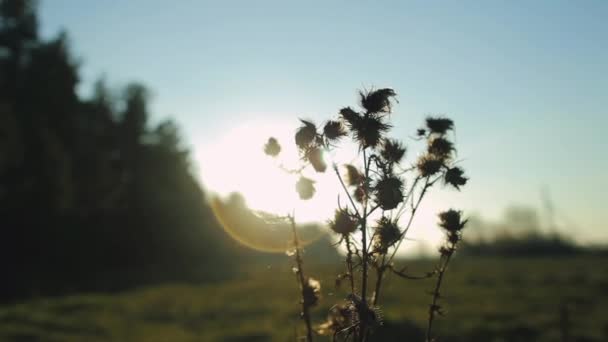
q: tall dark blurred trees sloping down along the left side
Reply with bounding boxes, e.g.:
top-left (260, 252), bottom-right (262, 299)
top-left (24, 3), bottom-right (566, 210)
top-left (0, 0), bottom-right (234, 300)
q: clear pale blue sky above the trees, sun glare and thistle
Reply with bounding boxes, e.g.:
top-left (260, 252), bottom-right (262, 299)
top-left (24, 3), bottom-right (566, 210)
top-left (40, 0), bottom-right (608, 242)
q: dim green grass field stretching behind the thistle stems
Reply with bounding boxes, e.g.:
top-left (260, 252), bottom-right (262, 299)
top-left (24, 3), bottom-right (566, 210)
top-left (0, 257), bottom-right (608, 342)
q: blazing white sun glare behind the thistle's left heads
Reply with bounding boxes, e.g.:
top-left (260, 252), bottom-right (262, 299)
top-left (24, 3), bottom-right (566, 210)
top-left (197, 122), bottom-right (340, 223)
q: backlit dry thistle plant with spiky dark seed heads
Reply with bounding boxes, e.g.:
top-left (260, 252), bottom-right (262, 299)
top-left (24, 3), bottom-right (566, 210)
top-left (264, 88), bottom-right (468, 341)
